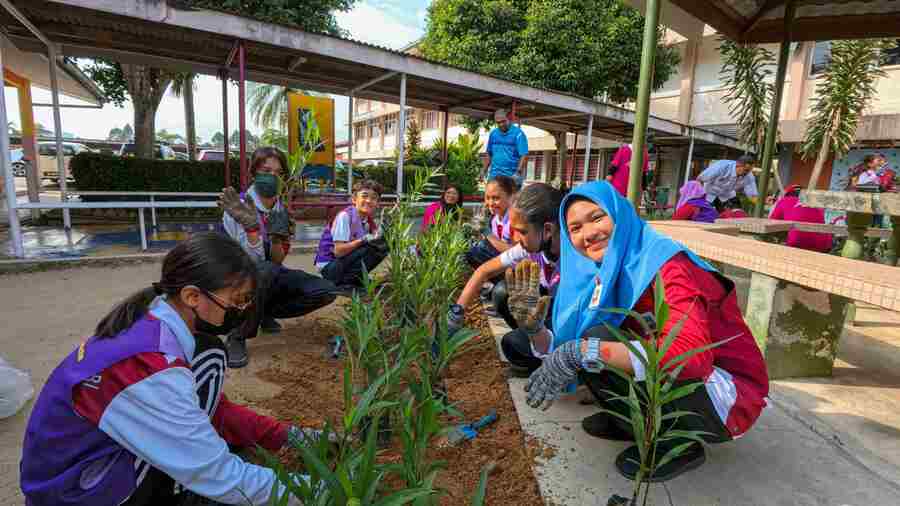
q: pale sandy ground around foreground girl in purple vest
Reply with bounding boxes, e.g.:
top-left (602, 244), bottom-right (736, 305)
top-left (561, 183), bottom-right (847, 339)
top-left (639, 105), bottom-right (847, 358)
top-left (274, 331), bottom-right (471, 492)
top-left (0, 256), bottom-right (324, 506)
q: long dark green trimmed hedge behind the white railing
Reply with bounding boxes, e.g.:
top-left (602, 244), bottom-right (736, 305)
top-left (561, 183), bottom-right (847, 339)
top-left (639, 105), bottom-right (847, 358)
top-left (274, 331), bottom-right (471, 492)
top-left (69, 153), bottom-right (240, 201)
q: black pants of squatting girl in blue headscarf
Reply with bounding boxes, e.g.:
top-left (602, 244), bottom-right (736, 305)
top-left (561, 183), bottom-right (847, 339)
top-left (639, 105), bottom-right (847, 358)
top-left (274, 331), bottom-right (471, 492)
top-left (579, 326), bottom-right (731, 443)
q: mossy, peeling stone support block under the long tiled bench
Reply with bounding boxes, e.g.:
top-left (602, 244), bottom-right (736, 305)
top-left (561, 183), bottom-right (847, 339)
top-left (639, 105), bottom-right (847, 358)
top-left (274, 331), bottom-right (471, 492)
top-left (744, 272), bottom-right (851, 380)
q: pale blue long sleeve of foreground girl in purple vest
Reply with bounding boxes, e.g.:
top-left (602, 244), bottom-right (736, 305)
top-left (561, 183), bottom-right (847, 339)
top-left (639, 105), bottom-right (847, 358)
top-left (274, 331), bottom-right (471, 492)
top-left (99, 367), bottom-right (283, 505)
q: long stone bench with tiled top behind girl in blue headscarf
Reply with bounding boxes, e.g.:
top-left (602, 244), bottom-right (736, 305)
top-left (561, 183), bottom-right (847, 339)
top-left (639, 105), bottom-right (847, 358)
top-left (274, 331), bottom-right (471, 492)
top-left (656, 226), bottom-right (900, 379)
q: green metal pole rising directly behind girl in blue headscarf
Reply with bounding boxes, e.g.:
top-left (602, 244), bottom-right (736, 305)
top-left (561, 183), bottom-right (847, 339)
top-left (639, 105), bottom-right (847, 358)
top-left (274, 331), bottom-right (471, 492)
top-left (628, 0), bottom-right (661, 209)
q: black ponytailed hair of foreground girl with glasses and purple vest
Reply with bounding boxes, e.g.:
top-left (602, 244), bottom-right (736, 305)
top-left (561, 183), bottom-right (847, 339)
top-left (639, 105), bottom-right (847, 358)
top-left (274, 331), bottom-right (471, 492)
top-left (94, 232), bottom-right (256, 338)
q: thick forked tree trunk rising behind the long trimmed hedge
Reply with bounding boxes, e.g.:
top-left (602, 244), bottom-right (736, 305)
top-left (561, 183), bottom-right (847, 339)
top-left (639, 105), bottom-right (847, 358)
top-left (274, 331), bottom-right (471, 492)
top-left (121, 64), bottom-right (172, 158)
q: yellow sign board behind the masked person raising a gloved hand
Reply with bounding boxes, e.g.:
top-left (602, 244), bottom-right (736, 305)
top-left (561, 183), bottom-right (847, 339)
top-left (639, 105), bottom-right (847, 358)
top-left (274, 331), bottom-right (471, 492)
top-left (288, 93), bottom-right (334, 167)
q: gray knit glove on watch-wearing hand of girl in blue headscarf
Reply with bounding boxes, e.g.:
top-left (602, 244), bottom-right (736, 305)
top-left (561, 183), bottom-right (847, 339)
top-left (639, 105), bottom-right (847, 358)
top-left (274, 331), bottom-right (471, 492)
top-left (525, 339), bottom-right (582, 411)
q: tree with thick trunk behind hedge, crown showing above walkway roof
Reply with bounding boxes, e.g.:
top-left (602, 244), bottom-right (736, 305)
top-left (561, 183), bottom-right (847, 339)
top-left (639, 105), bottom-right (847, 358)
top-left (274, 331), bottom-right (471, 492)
top-left (79, 0), bottom-right (356, 158)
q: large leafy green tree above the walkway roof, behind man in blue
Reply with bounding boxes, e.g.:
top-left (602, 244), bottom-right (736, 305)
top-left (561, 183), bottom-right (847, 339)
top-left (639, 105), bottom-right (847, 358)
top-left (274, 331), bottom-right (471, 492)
top-left (421, 0), bottom-right (678, 102)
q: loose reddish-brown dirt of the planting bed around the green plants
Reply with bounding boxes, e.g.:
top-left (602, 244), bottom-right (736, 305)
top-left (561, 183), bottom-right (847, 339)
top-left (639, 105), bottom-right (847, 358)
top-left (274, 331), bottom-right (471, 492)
top-left (243, 300), bottom-right (543, 506)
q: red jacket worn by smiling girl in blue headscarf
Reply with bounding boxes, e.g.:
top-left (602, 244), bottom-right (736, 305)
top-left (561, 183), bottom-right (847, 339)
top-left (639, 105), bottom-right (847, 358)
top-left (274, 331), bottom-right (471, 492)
top-left (623, 253), bottom-right (769, 437)
